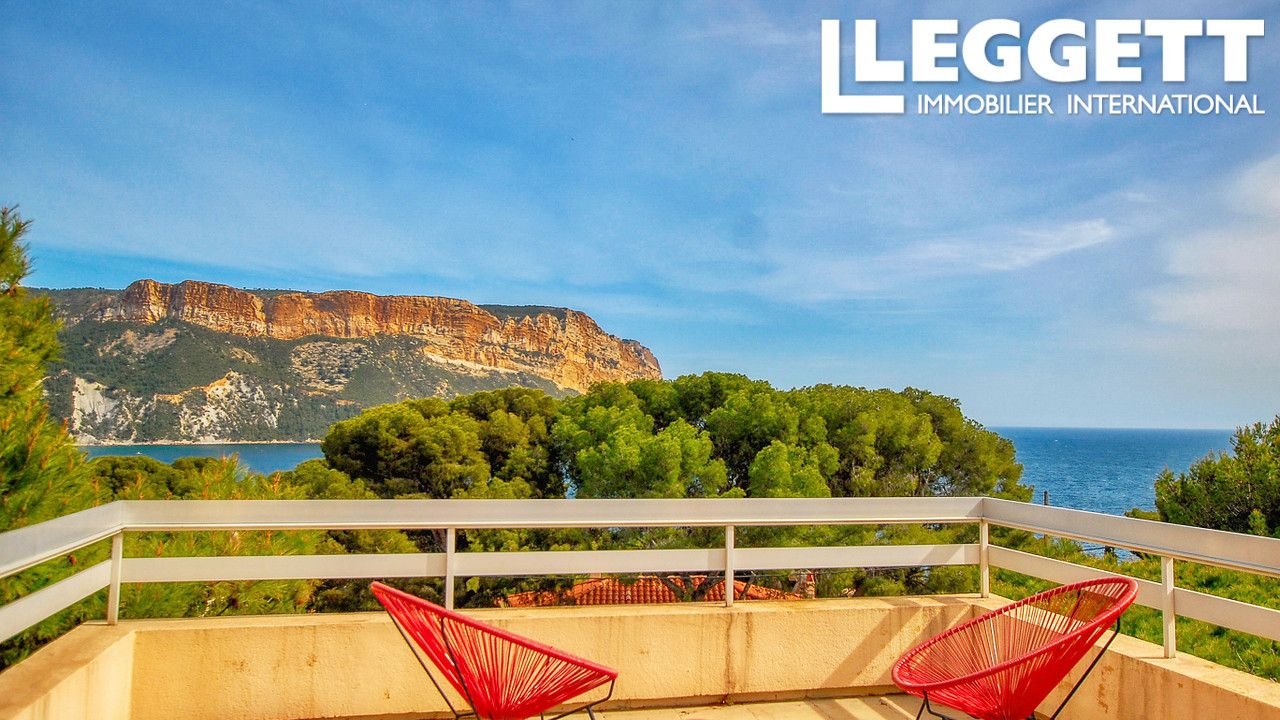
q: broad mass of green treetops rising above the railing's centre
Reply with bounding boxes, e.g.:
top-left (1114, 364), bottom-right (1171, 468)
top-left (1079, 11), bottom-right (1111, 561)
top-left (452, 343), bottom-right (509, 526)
top-left (323, 373), bottom-right (1030, 500)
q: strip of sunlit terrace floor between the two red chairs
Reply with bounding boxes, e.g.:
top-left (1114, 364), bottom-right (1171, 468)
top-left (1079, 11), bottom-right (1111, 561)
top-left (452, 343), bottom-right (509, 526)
top-left (596, 694), bottom-right (969, 720)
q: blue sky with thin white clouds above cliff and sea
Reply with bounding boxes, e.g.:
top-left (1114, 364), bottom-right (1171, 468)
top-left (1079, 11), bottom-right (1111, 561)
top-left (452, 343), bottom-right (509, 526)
top-left (0, 0), bottom-right (1280, 428)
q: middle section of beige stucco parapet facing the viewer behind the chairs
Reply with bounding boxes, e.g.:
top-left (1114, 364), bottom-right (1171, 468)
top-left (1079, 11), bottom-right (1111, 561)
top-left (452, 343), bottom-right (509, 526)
top-left (124, 598), bottom-right (972, 720)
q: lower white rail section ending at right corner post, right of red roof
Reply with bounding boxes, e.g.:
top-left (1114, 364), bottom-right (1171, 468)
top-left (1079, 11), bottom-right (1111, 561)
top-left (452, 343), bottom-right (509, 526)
top-left (733, 544), bottom-right (978, 570)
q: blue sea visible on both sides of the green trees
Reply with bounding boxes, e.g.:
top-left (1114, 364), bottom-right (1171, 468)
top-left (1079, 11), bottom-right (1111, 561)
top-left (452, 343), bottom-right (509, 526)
top-left (86, 428), bottom-right (1231, 514)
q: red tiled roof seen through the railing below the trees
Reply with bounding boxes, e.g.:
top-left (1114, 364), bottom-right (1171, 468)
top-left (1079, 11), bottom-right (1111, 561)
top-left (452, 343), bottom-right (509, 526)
top-left (498, 575), bottom-right (804, 607)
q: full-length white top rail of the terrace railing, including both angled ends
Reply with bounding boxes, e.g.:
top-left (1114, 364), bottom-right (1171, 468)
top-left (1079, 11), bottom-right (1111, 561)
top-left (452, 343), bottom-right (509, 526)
top-left (0, 498), bottom-right (1280, 577)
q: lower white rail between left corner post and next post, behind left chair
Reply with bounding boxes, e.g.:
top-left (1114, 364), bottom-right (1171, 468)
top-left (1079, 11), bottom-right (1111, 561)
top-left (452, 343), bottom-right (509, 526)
top-left (120, 552), bottom-right (444, 583)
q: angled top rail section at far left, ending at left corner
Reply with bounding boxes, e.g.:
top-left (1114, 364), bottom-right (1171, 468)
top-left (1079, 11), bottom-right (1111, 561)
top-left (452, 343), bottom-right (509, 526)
top-left (0, 502), bottom-right (124, 578)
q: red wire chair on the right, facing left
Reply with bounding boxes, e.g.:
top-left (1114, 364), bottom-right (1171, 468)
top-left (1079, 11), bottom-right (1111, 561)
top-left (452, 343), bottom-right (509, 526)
top-left (893, 578), bottom-right (1138, 720)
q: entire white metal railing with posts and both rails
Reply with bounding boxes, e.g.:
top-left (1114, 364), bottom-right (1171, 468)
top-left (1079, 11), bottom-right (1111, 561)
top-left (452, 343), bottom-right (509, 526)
top-left (0, 497), bottom-right (1280, 657)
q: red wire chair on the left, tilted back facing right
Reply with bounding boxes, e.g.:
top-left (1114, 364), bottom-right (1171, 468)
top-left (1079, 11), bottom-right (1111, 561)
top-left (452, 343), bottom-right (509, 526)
top-left (370, 583), bottom-right (618, 720)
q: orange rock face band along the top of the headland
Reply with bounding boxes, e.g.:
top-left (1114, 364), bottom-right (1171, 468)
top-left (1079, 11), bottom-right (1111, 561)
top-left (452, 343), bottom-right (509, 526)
top-left (97, 279), bottom-right (662, 392)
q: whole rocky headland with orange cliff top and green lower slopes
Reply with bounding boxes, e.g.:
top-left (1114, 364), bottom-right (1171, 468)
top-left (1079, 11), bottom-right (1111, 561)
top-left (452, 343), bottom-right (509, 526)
top-left (41, 279), bottom-right (662, 442)
